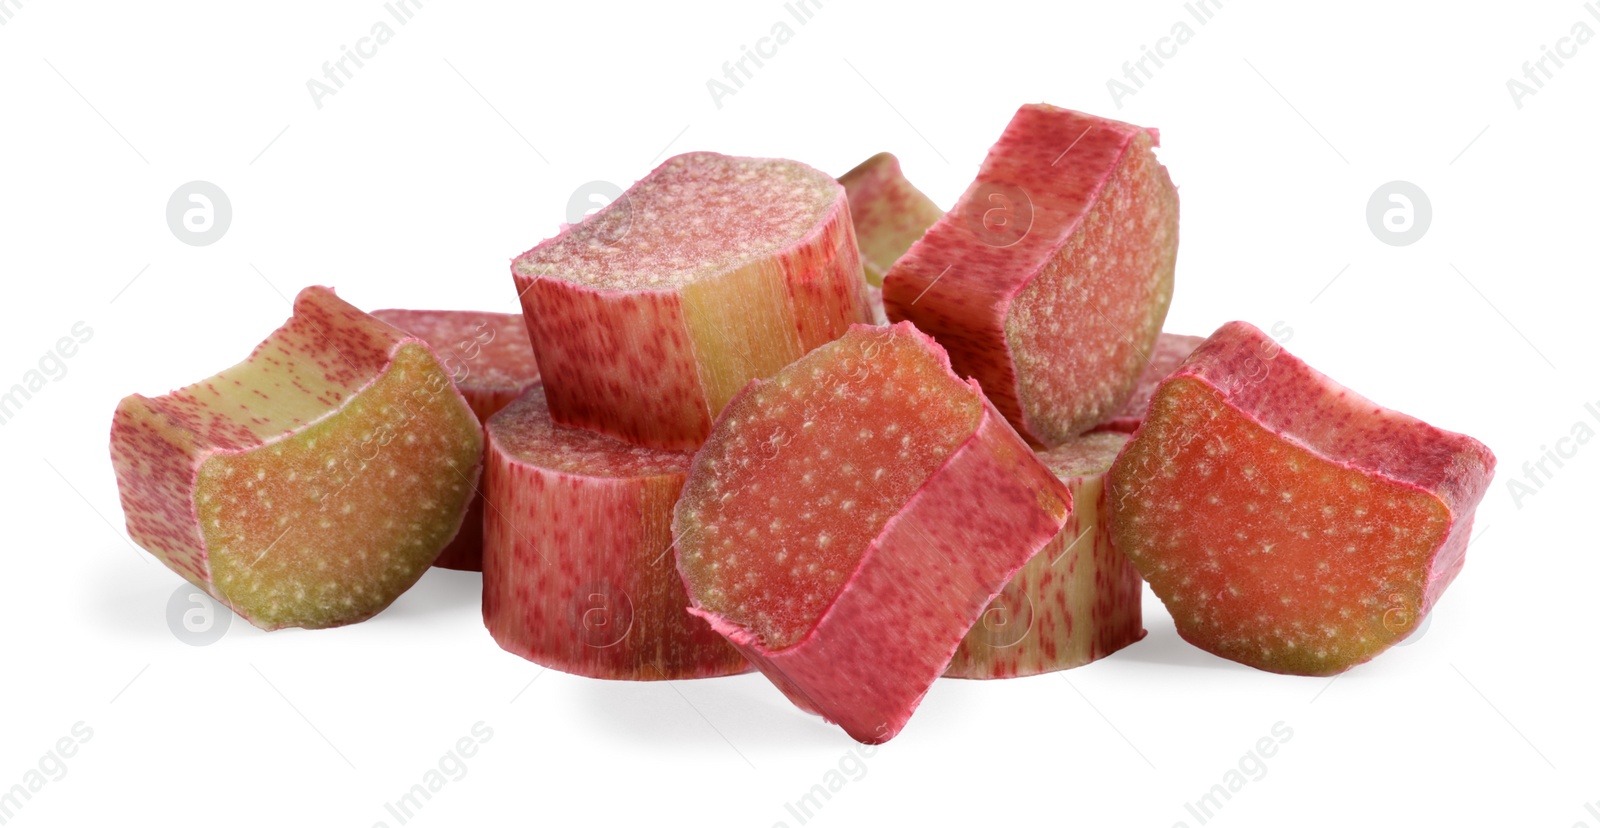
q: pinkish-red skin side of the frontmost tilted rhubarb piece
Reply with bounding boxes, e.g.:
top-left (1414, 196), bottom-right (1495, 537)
top-left (678, 324), bottom-right (1072, 745)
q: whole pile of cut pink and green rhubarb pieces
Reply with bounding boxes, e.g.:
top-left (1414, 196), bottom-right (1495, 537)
top-left (110, 104), bottom-right (1494, 742)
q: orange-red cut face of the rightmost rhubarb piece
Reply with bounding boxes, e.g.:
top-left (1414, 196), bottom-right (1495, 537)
top-left (1114, 377), bottom-right (1451, 675)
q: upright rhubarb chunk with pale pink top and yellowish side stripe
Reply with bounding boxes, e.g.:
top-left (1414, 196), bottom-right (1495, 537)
top-left (512, 152), bottom-right (870, 449)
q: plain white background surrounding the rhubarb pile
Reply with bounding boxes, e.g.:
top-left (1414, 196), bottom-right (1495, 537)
top-left (0, 0), bottom-right (1600, 828)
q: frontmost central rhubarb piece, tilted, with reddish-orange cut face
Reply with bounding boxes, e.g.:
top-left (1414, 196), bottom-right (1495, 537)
top-left (674, 323), bottom-right (1072, 743)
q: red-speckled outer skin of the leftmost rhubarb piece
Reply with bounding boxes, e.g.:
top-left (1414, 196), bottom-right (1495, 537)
top-left (110, 286), bottom-right (477, 620)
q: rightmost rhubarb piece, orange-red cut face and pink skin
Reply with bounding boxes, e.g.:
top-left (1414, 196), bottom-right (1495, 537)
top-left (1110, 321), bottom-right (1494, 676)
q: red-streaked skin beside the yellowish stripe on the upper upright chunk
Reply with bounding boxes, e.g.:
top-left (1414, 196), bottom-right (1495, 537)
top-left (512, 158), bottom-right (870, 451)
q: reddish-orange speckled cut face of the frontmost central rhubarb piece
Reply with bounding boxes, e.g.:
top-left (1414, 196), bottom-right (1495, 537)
top-left (678, 326), bottom-right (982, 649)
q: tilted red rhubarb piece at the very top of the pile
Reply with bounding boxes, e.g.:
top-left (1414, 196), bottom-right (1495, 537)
top-left (883, 104), bottom-right (1178, 446)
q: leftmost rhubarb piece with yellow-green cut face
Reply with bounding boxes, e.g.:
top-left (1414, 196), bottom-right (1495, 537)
top-left (110, 288), bottom-right (483, 630)
